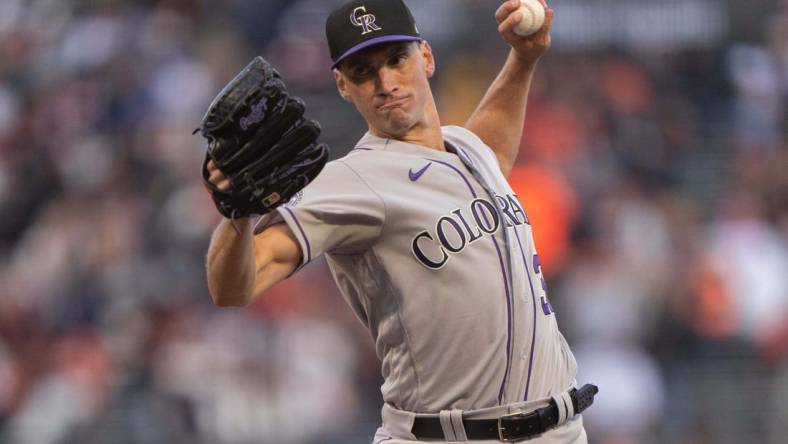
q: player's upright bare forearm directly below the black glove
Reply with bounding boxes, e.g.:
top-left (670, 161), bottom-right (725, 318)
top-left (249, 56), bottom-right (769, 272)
top-left (206, 218), bottom-right (255, 307)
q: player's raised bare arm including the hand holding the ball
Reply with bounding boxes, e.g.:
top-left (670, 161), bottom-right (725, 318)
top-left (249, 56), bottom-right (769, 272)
top-left (465, 0), bottom-right (553, 176)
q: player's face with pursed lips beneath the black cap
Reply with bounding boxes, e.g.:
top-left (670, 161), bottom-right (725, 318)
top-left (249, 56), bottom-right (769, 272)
top-left (335, 42), bottom-right (435, 138)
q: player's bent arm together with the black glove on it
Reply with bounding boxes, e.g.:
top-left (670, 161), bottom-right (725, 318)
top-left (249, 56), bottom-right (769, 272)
top-left (199, 57), bottom-right (328, 306)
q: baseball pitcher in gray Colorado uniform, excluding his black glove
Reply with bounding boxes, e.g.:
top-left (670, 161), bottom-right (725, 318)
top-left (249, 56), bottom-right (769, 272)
top-left (207, 0), bottom-right (596, 444)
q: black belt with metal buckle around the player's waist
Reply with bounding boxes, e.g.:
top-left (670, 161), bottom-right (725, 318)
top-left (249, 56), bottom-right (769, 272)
top-left (411, 384), bottom-right (599, 442)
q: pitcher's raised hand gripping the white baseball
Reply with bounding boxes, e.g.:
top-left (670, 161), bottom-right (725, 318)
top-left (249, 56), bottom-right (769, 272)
top-left (495, 0), bottom-right (554, 63)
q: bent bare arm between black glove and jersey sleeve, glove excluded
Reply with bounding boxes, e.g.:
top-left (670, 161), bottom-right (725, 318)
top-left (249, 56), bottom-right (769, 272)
top-left (206, 218), bottom-right (301, 307)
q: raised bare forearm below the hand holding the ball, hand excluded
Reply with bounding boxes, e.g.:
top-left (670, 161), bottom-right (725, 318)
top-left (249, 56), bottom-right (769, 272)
top-left (465, 51), bottom-right (536, 176)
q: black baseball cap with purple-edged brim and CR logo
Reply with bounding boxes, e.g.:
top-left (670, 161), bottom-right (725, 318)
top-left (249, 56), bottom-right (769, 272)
top-left (326, 0), bottom-right (421, 68)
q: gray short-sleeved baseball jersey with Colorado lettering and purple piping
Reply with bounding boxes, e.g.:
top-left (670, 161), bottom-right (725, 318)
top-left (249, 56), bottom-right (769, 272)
top-left (256, 126), bottom-right (577, 413)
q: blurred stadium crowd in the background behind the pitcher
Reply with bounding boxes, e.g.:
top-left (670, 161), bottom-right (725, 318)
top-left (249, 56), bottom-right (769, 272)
top-left (0, 0), bottom-right (788, 444)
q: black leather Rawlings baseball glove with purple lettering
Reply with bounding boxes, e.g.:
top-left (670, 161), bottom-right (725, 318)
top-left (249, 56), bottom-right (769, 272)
top-left (200, 57), bottom-right (328, 219)
